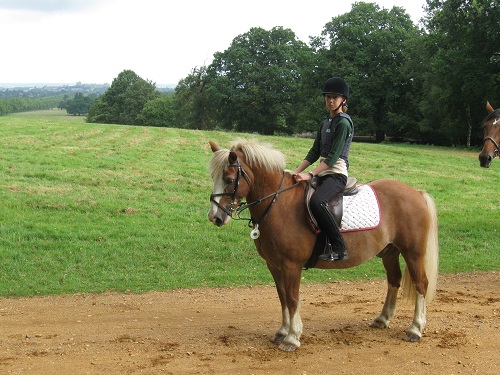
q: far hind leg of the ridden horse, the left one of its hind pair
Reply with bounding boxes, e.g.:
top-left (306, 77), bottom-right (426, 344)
top-left (370, 248), bottom-right (402, 328)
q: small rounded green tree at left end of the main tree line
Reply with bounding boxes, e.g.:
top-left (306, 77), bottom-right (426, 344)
top-left (87, 70), bottom-right (160, 125)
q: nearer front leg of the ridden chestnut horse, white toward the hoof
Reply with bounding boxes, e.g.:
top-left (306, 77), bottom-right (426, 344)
top-left (279, 261), bottom-right (302, 352)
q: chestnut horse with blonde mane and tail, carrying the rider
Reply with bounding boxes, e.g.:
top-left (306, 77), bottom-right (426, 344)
top-left (208, 139), bottom-right (439, 352)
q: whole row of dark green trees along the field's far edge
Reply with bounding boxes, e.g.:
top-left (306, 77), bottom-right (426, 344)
top-left (3, 0), bottom-right (500, 146)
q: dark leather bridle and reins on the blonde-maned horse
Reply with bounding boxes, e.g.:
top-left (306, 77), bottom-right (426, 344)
top-left (210, 160), bottom-right (299, 227)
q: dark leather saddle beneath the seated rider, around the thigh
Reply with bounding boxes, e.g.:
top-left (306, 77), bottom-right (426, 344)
top-left (305, 177), bottom-right (358, 234)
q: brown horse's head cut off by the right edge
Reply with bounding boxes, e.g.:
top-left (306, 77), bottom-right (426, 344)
top-left (479, 101), bottom-right (500, 168)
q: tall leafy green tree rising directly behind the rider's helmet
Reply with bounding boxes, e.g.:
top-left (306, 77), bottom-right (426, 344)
top-left (313, 2), bottom-right (420, 139)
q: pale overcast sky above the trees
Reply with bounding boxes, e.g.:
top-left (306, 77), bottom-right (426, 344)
top-left (0, 0), bottom-right (425, 85)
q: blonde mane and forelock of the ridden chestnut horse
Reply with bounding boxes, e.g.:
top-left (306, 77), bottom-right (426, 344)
top-left (209, 138), bottom-right (286, 180)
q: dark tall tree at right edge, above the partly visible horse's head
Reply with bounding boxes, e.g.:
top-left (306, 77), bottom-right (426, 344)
top-left (421, 0), bottom-right (500, 145)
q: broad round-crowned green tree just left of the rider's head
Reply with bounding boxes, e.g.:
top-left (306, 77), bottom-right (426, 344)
top-left (207, 27), bottom-right (311, 135)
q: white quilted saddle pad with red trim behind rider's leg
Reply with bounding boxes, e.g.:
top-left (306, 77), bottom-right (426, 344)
top-left (340, 185), bottom-right (380, 232)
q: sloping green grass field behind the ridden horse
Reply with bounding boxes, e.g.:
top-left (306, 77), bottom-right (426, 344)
top-left (0, 110), bottom-right (500, 296)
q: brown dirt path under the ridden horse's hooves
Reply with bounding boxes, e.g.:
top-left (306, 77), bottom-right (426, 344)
top-left (0, 272), bottom-right (500, 375)
